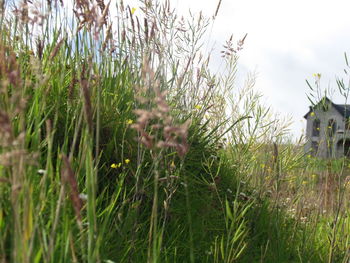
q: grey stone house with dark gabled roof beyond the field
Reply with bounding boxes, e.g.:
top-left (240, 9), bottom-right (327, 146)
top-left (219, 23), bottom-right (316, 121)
top-left (304, 97), bottom-right (350, 158)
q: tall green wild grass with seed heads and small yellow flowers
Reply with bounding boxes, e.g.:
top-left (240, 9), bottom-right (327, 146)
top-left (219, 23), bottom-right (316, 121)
top-left (0, 0), bottom-right (350, 263)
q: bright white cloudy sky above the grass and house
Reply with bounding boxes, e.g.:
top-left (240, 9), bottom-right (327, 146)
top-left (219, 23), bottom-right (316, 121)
top-left (125, 0), bottom-right (350, 139)
